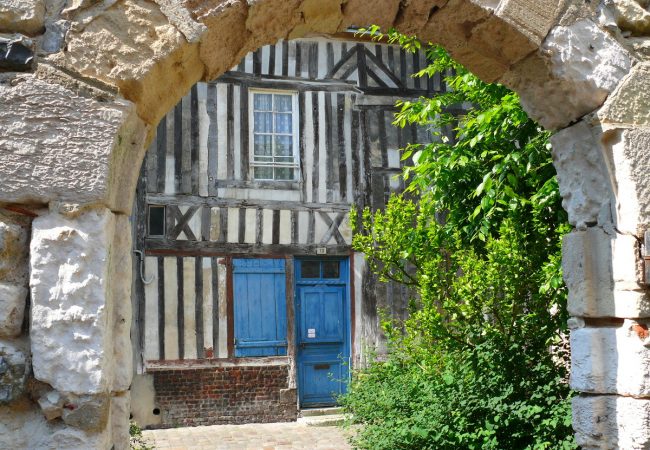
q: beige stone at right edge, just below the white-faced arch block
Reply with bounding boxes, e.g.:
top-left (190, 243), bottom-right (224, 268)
top-left (597, 62), bottom-right (650, 127)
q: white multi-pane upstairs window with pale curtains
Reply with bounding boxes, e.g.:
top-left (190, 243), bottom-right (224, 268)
top-left (250, 90), bottom-right (299, 181)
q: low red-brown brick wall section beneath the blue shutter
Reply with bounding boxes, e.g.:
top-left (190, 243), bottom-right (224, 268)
top-left (153, 365), bottom-right (297, 427)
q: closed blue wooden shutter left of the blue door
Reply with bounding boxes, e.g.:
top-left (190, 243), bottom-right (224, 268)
top-left (233, 259), bottom-right (287, 357)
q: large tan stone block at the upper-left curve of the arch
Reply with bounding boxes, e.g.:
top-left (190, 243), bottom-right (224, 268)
top-left (58, 0), bottom-right (205, 125)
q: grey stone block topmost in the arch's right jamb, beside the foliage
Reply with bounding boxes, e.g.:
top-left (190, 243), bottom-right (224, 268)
top-left (551, 122), bottom-right (613, 229)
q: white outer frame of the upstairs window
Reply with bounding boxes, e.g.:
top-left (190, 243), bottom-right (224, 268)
top-left (248, 88), bottom-right (300, 182)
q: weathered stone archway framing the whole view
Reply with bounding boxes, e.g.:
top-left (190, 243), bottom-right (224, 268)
top-left (0, 0), bottom-right (650, 448)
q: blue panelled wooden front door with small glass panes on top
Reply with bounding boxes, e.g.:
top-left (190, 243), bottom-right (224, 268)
top-left (296, 260), bottom-right (350, 408)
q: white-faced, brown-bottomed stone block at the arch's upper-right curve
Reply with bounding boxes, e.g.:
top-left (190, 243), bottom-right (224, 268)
top-left (500, 20), bottom-right (632, 130)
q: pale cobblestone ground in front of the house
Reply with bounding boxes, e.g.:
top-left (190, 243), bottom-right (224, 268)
top-left (142, 422), bottom-right (352, 450)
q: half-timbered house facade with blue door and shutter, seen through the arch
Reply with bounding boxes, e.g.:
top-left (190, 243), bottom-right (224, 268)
top-left (132, 35), bottom-right (445, 426)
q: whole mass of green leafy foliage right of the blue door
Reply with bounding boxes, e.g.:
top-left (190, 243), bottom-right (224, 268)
top-left (342, 29), bottom-right (574, 449)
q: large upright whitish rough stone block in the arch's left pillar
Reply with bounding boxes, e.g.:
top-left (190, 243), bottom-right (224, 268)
top-left (30, 209), bottom-right (126, 394)
